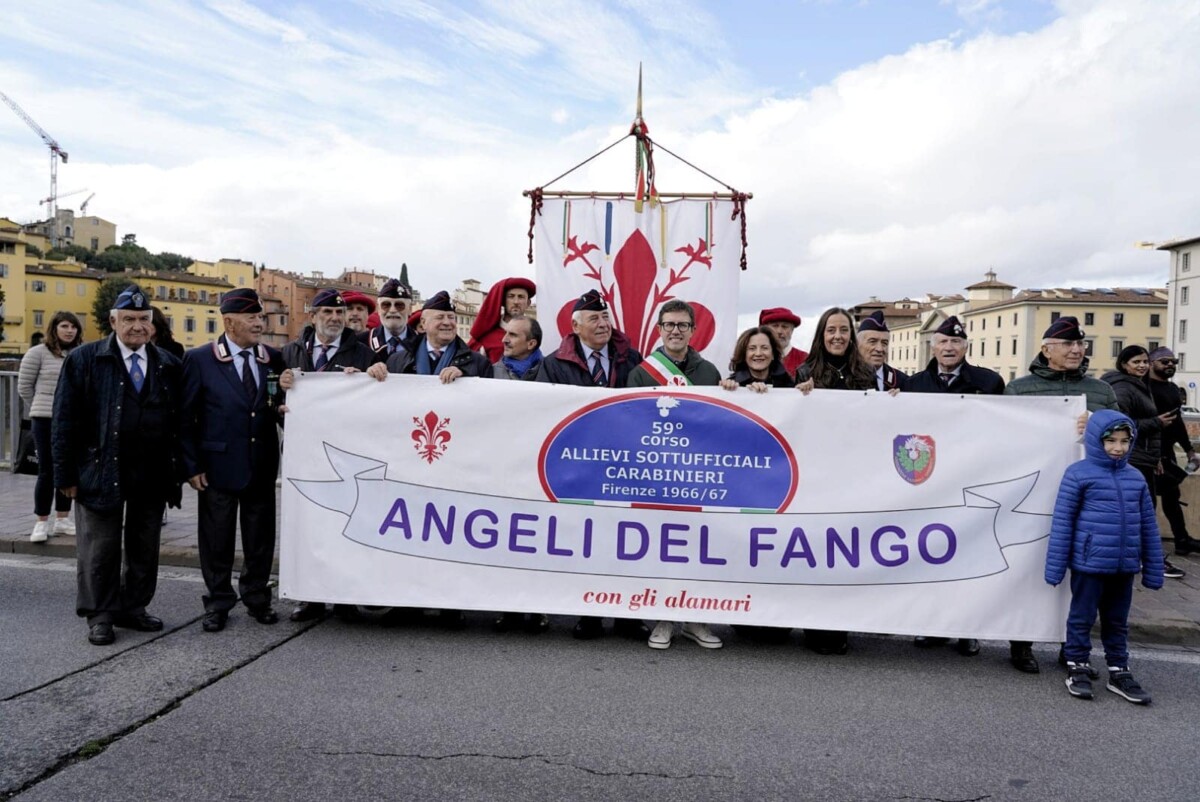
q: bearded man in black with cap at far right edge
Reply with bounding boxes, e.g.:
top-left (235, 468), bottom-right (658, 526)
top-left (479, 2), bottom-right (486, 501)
top-left (1146, 348), bottom-right (1200, 564)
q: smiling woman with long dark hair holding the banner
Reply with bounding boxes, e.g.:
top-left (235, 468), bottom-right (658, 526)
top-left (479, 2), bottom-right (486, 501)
top-left (796, 306), bottom-right (876, 654)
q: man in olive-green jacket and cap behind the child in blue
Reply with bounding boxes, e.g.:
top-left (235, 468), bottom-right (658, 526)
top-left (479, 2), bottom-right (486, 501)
top-left (1004, 317), bottom-right (1121, 674)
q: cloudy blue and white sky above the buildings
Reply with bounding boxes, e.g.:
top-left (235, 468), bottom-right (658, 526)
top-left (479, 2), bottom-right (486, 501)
top-left (0, 0), bottom-right (1200, 340)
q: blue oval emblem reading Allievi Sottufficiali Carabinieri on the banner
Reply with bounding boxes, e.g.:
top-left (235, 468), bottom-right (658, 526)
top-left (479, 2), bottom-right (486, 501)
top-left (538, 393), bottom-right (799, 513)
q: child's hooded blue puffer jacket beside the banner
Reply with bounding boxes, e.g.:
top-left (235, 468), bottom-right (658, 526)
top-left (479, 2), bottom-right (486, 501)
top-left (1045, 409), bottom-right (1163, 589)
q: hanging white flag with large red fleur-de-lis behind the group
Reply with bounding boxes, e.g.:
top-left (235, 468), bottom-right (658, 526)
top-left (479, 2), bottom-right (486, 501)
top-left (536, 197), bottom-right (742, 375)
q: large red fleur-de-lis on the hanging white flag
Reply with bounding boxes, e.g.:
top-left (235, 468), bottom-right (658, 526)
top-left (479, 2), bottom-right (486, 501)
top-left (558, 231), bottom-right (716, 354)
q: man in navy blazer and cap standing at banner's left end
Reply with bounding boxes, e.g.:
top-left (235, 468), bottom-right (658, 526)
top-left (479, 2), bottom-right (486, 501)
top-left (182, 289), bottom-right (284, 633)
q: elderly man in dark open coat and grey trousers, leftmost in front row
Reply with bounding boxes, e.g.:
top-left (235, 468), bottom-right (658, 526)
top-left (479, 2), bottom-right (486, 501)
top-left (53, 287), bottom-right (184, 646)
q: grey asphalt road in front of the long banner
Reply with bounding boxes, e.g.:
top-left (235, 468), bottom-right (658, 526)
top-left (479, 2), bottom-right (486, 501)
top-left (0, 557), bottom-right (1200, 801)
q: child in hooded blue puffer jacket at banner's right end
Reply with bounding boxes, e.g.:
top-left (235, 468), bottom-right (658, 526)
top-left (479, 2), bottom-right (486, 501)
top-left (1045, 409), bottom-right (1163, 705)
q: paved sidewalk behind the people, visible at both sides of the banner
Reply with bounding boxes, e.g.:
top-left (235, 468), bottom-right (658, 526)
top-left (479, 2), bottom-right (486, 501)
top-left (0, 471), bottom-right (1200, 648)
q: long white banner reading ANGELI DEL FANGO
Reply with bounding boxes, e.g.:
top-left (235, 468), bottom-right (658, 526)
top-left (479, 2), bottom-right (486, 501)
top-left (280, 373), bottom-right (1085, 641)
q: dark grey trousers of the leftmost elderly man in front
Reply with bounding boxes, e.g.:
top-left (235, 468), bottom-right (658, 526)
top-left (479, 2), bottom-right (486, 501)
top-left (76, 498), bottom-right (167, 627)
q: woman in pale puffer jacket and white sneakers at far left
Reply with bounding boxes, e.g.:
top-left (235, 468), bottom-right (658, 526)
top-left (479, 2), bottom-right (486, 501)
top-left (17, 312), bottom-right (83, 543)
